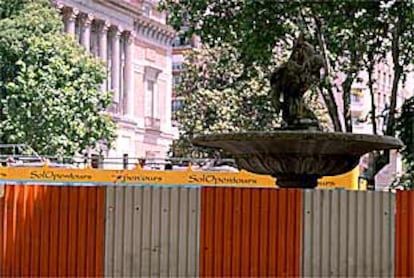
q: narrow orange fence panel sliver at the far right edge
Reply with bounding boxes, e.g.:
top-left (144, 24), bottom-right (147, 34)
top-left (395, 191), bottom-right (414, 277)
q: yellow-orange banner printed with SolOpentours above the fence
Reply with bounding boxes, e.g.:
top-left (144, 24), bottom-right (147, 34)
top-left (0, 165), bottom-right (358, 189)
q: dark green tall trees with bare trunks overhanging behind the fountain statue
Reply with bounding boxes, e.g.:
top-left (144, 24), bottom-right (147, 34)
top-left (161, 0), bottom-right (414, 187)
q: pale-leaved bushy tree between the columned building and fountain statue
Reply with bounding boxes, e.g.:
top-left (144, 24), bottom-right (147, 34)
top-left (173, 46), bottom-right (279, 156)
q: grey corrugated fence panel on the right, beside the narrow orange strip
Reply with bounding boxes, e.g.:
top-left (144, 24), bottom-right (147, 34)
top-left (302, 190), bottom-right (395, 277)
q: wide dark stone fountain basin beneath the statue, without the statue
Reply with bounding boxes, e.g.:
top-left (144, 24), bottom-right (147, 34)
top-left (192, 130), bottom-right (403, 188)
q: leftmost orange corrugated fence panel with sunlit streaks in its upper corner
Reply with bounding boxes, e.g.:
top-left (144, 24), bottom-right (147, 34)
top-left (0, 185), bottom-right (105, 277)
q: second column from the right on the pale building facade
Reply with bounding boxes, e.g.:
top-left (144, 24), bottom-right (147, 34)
top-left (111, 26), bottom-right (122, 112)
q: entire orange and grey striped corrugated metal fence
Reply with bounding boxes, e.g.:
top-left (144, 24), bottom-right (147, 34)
top-left (0, 184), bottom-right (414, 277)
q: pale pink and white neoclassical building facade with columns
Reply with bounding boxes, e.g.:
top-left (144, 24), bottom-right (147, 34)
top-left (53, 0), bottom-right (175, 158)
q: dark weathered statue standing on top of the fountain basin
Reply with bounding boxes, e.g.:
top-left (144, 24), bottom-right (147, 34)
top-left (270, 33), bottom-right (323, 130)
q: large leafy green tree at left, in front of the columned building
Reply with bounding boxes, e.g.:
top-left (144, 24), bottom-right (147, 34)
top-left (0, 0), bottom-right (115, 155)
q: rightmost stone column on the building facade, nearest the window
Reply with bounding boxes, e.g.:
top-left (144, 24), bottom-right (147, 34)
top-left (123, 31), bottom-right (135, 117)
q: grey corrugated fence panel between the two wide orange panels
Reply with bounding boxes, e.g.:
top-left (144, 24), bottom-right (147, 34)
top-left (105, 187), bottom-right (200, 277)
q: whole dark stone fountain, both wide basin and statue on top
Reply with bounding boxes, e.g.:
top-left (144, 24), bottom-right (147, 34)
top-left (192, 34), bottom-right (402, 188)
